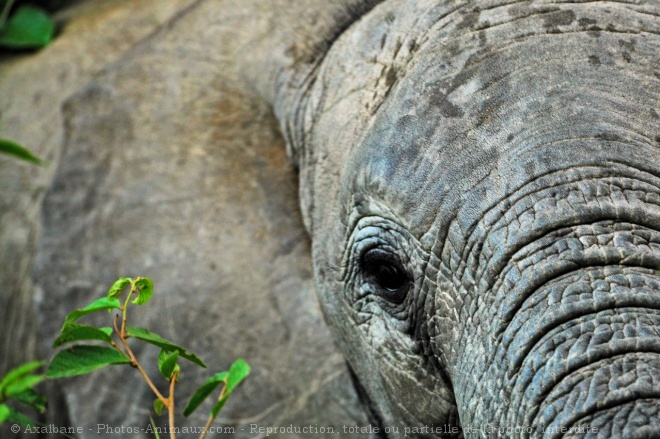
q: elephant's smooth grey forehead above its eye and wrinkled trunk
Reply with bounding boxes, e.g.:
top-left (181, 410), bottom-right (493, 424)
top-left (342, 2), bottom-right (660, 241)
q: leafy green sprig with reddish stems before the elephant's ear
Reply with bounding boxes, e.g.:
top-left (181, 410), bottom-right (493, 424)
top-left (46, 277), bottom-right (250, 439)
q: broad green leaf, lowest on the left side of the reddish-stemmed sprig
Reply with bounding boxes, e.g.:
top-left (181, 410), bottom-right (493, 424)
top-left (46, 345), bottom-right (131, 378)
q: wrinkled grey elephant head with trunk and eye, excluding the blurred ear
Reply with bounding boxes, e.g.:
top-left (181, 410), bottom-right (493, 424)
top-left (266, 0), bottom-right (660, 437)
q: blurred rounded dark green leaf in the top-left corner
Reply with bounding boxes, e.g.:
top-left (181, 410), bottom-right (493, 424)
top-left (0, 5), bottom-right (55, 49)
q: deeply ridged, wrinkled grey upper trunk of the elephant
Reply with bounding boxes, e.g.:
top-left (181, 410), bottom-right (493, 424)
top-left (438, 169), bottom-right (660, 437)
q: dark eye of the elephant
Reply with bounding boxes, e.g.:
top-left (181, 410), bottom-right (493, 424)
top-left (362, 249), bottom-right (410, 304)
